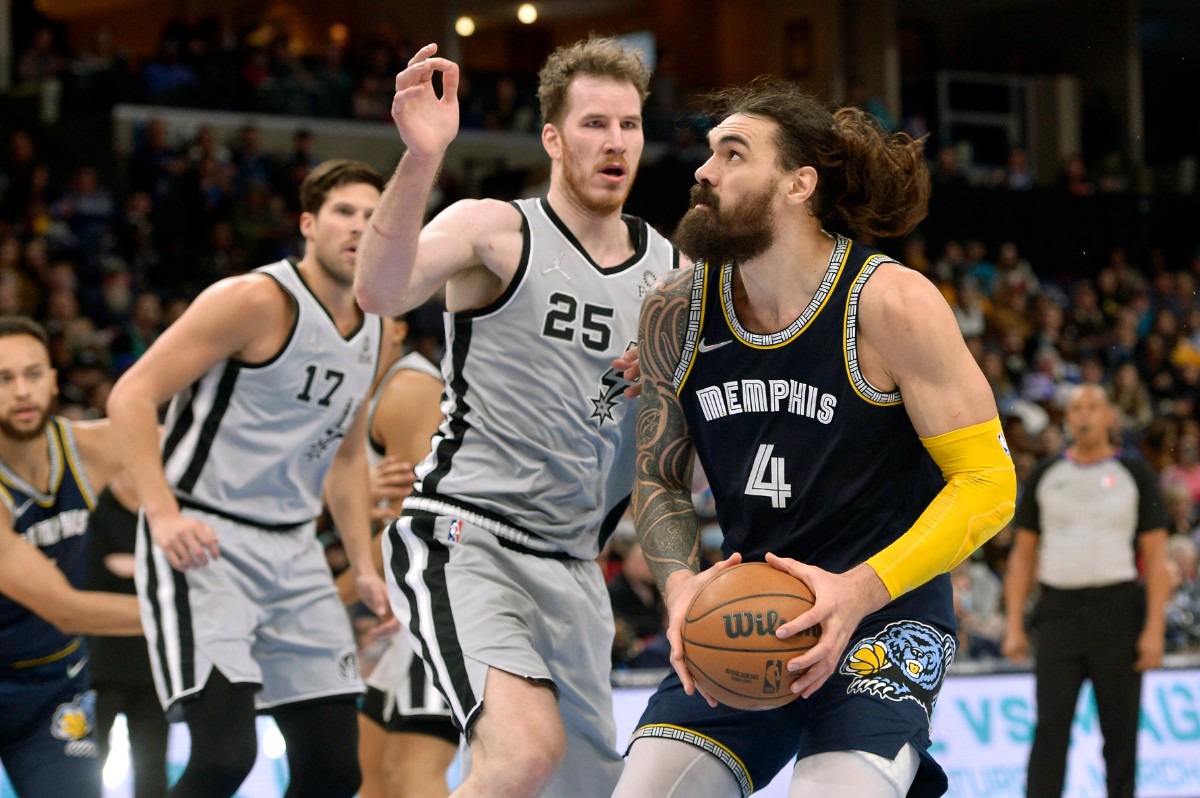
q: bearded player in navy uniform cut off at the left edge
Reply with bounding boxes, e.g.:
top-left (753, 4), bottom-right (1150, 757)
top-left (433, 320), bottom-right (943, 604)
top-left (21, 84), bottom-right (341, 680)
top-left (0, 316), bottom-right (142, 798)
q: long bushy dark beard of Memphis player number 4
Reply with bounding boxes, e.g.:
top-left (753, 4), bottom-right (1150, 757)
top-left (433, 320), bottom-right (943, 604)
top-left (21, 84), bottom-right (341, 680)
top-left (673, 184), bottom-right (775, 265)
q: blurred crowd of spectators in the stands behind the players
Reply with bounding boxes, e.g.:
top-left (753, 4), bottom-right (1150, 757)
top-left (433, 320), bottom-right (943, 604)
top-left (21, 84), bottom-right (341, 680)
top-left (0, 12), bottom-right (1200, 666)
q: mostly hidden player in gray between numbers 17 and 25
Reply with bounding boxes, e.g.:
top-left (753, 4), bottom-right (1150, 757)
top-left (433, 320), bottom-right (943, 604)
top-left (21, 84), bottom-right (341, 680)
top-left (359, 317), bottom-right (458, 798)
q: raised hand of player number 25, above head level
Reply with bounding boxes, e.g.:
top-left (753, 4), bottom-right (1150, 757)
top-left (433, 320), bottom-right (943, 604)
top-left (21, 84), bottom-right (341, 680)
top-left (391, 44), bottom-right (458, 158)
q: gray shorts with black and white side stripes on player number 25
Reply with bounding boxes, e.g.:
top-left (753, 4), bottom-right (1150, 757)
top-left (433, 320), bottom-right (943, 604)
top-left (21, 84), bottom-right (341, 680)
top-left (383, 511), bottom-right (622, 798)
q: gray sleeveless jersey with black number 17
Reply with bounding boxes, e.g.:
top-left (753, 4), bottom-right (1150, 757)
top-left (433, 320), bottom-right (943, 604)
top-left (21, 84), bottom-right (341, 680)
top-left (163, 260), bottom-right (383, 528)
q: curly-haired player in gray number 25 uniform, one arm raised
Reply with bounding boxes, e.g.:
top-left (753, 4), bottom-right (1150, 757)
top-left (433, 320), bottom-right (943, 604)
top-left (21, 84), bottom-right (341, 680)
top-left (355, 37), bottom-right (678, 797)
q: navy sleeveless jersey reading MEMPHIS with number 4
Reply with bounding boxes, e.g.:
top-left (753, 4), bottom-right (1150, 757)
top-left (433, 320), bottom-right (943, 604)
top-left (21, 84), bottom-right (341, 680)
top-left (674, 236), bottom-right (953, 624)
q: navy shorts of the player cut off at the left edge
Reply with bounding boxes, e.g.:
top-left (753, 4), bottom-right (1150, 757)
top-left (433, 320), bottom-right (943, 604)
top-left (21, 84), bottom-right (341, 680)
top-left (0, 647), bottom-right (103, 798)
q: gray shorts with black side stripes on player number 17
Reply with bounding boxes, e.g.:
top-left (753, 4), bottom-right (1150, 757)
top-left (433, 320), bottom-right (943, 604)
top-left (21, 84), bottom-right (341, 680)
top-left (134, 510), bottom-right (362, 719)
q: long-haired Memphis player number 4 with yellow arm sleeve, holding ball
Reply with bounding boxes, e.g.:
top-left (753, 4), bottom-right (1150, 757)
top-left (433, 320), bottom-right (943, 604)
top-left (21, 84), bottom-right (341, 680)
top-left (614, 79), bottom-right (1016, 798)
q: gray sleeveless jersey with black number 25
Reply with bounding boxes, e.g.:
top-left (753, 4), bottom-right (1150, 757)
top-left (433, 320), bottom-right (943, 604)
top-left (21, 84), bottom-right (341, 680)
top-left (404, 199), bottom-right (678, 559)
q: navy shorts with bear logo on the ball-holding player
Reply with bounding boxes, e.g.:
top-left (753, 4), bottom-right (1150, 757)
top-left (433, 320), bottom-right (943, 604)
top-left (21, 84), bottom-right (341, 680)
top-left (626, 614), bottom-right (955, 798)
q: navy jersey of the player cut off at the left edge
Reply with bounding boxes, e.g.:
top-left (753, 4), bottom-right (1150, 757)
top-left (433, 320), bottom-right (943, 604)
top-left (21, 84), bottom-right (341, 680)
top-left (0, 418), bottom-right (96, 666)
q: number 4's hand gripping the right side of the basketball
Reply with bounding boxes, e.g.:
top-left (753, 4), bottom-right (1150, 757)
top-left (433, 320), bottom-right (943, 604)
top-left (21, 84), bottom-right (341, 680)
top-left (767, 554), bottom-right (890, 698)
